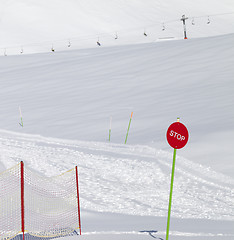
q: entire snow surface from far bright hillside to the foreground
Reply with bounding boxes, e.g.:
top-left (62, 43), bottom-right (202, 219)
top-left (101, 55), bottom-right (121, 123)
top-left (0, 0), bottom-right (234, 240)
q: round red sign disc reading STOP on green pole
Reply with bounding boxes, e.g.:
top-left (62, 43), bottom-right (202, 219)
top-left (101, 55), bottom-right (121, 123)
top-left (167, 122), bottom-right (189, 149)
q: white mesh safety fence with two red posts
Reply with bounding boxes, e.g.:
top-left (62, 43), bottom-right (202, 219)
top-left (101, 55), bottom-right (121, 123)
top-left (0, 162), bottom-right (81, 240)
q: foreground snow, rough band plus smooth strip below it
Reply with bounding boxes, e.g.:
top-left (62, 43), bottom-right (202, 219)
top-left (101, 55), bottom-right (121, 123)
top-left (0, 126), bottom-right (234, 240)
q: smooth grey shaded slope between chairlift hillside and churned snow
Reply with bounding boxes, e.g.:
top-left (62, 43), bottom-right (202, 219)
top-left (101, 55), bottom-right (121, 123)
top-left (0, 34), bottom-right (234, 176)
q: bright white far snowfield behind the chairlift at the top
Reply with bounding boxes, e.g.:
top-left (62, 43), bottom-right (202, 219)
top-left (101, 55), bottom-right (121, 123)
top-left (0, 0), bottom-right (234, 54)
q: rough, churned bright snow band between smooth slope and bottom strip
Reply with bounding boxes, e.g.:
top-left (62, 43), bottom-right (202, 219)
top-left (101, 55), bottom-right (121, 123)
top-left (0, 130), bottom-right (234, 220)
